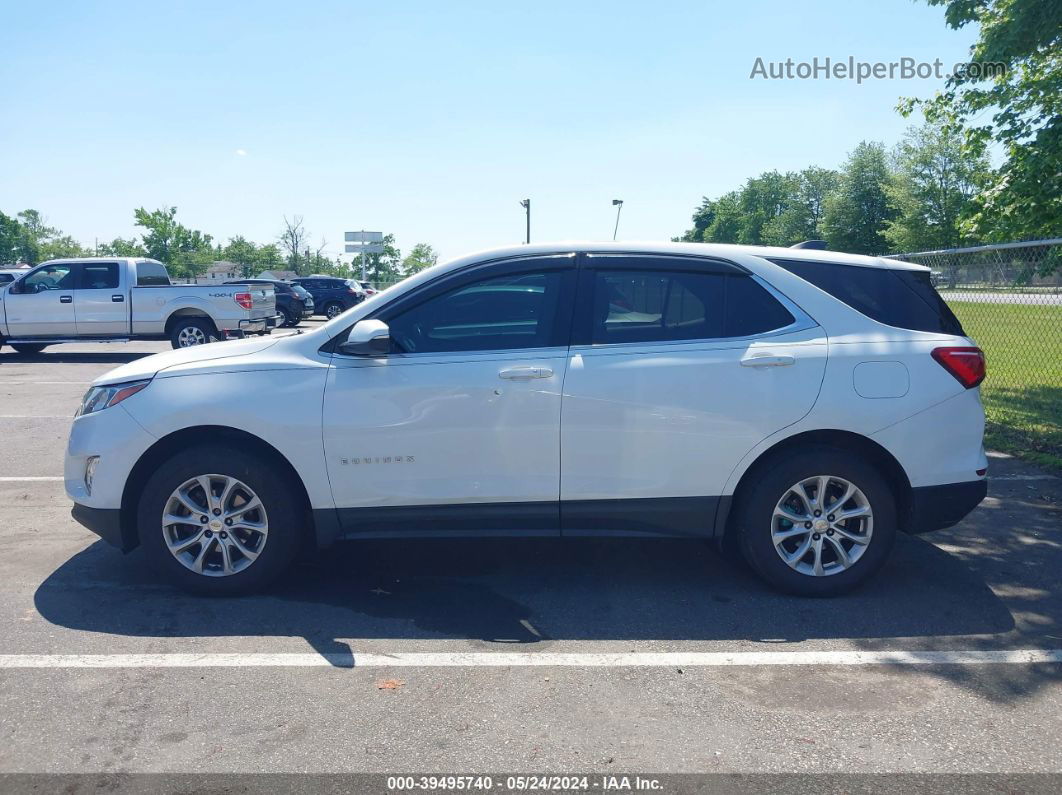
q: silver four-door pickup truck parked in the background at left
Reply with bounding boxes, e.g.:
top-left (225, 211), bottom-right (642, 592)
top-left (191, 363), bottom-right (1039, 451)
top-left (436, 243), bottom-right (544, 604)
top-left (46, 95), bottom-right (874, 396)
top-left (0, 257), bottom-right (284, 353)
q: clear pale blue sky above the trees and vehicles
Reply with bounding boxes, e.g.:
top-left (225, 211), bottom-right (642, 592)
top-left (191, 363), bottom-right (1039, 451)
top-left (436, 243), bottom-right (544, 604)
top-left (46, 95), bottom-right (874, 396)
top-left (0, 0), bottom-right (975, 257)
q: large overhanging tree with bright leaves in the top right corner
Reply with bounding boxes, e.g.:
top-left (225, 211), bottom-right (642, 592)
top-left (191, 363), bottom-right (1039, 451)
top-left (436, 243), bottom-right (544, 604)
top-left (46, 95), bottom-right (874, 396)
top-left (900, 0), bottom-right (1062, 241)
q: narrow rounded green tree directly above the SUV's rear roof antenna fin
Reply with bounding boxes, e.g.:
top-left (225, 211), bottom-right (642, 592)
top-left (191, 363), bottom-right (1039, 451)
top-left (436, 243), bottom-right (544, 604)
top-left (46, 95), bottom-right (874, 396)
top-left (820, 141), bottom-right (895, 254)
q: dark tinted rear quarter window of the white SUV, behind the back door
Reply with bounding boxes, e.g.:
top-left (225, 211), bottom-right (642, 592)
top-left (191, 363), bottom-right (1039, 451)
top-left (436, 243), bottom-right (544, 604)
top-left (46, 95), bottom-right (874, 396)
top-left (771, 259), bottom-right (965, 336)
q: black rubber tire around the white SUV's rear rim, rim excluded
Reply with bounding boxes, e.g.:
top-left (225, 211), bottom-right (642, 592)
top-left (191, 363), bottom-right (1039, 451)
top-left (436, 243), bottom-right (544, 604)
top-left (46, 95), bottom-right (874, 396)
top-left (735, 446), bottom-right (896, 597)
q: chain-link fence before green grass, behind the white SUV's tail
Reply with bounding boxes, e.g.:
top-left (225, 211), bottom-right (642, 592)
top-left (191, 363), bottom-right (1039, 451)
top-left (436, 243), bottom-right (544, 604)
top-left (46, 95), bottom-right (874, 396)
top-left (894, 238), bottom-right (1062, 470)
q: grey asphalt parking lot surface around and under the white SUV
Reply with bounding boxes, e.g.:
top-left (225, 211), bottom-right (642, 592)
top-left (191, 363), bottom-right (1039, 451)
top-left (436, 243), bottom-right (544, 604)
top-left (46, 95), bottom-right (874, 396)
top-left (0, 322), bottom-right (1062, 773)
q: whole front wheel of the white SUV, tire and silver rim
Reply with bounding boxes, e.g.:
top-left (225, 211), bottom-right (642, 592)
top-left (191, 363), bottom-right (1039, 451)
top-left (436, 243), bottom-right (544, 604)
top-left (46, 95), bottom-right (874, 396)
top-left (137, 445), bottom-right (303, 595)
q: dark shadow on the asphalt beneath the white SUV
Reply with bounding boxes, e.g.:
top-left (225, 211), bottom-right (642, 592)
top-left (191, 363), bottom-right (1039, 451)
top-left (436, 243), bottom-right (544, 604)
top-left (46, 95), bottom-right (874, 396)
top-left (34, 536), bottom-right (1014, 666)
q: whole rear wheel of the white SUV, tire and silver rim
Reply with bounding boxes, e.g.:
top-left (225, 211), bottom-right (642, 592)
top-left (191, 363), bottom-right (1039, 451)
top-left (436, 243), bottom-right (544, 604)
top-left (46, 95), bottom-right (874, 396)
top-left (737, 447), bottom-right (896, 597)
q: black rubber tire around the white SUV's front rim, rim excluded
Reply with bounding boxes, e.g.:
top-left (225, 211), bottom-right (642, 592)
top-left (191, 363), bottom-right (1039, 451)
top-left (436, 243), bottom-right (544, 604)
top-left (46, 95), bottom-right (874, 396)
top-left (137, 445), bottom-right (305, 597)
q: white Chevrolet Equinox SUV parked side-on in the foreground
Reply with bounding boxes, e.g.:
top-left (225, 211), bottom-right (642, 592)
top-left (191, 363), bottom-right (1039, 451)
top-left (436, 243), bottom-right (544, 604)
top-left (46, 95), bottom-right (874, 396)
top-left (66, 243), bottom-right (988, 594)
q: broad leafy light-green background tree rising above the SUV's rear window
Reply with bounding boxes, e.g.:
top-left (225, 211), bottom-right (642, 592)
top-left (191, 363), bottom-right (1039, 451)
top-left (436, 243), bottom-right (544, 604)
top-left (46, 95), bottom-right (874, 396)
top-left (885, 123), bottom-right (991, 252)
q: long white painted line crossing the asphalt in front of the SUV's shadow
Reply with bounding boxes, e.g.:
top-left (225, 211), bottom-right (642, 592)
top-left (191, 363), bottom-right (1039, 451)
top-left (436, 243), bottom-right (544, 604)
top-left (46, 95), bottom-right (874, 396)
top-left (0, 649), bottom-right (1062, 670)
